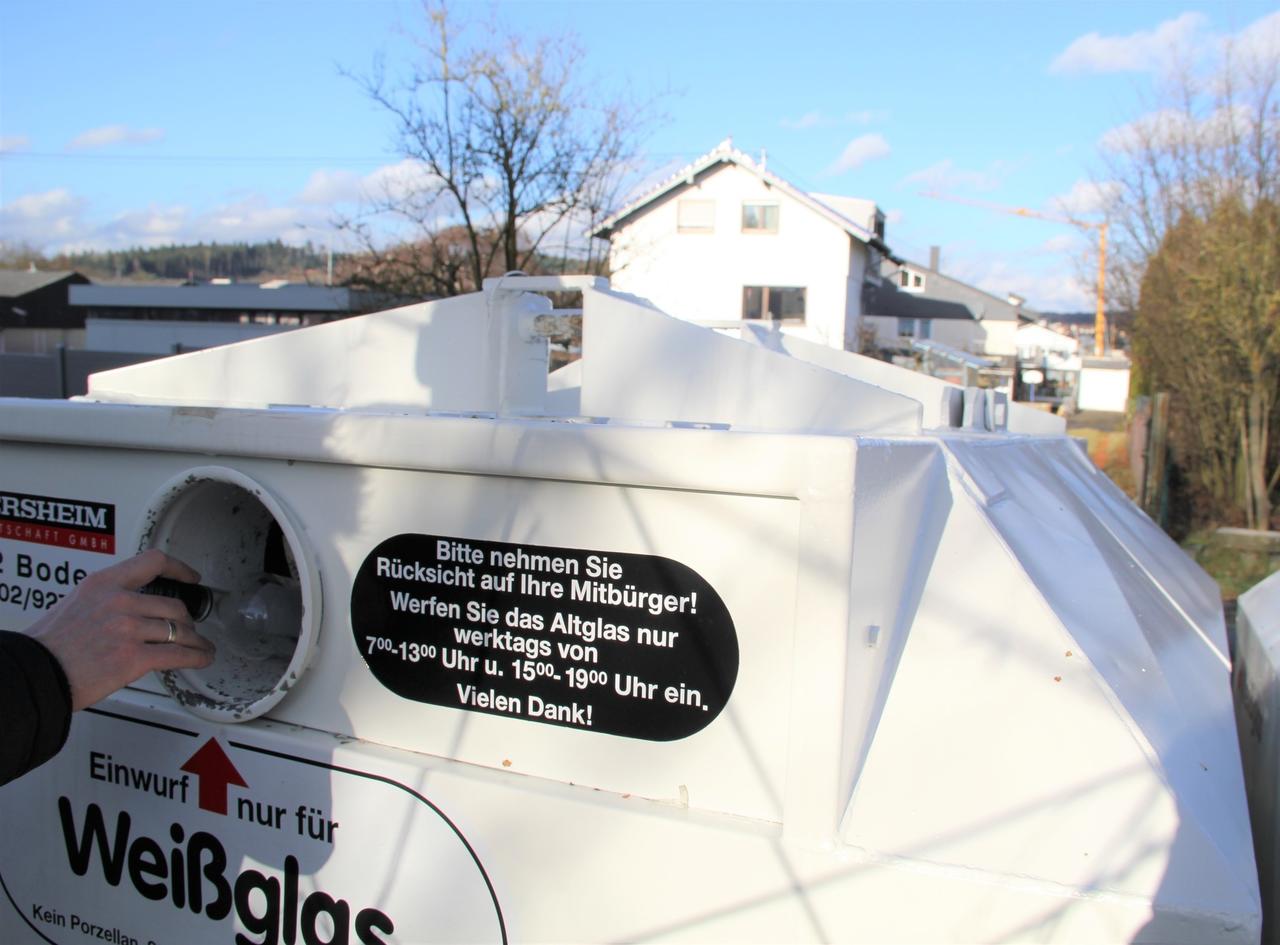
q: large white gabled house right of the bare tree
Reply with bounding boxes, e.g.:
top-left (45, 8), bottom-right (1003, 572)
top-left (591, 138), bottom-right (890, 351)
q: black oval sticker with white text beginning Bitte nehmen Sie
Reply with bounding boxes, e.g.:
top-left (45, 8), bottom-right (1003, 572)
top-left (351, 535), bottom-right (737, 741)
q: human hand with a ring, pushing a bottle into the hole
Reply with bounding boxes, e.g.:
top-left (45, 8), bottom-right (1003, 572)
top-left (28, 548), bottom-right (214, 709)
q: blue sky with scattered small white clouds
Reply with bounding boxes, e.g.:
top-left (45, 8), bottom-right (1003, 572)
top-left (0, 0), bottom-right (1280, 311)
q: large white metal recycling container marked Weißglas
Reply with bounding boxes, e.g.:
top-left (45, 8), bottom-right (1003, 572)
top-left (0, 277), bottom-right (1261, 945)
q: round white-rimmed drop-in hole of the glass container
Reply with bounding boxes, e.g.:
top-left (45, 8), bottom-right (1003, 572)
top-left (138, 467), bottom-right (320, 721)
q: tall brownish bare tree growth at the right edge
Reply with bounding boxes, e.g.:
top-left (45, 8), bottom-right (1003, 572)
top-left (1106, 40), bottom-right (1280, 528)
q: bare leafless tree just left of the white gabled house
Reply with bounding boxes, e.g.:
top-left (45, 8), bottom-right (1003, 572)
top-left (338, 3), bottom-right (650, 295)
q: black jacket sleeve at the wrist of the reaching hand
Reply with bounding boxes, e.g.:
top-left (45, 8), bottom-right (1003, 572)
top-left (0, 630), bottom-right (72, 784)
